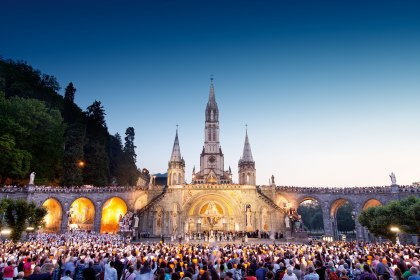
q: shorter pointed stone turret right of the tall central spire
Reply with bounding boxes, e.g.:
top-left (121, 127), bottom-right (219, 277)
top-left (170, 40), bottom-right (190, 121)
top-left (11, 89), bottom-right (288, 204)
top-left (238, 128), bottom-right (256, 185)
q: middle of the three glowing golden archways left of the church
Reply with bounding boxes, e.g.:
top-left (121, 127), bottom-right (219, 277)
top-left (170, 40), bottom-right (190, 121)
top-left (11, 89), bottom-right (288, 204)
top-left (69, 197), bottom-right (95, 230)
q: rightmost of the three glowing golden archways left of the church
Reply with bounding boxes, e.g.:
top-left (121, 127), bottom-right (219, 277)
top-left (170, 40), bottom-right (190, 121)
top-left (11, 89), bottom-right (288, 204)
top-left (100, 197), bottom-right (127, 234)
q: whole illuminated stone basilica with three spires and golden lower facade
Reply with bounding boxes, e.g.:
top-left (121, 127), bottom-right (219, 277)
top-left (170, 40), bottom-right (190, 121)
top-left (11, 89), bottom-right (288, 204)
top-left (140, 79), bottom-right (284, 235)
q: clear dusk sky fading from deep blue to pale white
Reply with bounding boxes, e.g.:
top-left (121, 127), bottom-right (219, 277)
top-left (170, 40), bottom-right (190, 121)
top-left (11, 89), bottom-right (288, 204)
top-left (0, 0), bottom-right (420, 187)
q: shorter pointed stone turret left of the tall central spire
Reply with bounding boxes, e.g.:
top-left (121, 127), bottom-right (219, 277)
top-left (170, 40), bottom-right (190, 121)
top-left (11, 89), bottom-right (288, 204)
top-left (168, 128), bottom-right (185, 186)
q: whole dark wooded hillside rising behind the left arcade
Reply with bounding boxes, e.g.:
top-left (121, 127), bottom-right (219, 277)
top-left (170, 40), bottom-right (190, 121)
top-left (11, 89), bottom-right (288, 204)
top-left (0, 58), bottom-right (137, 186)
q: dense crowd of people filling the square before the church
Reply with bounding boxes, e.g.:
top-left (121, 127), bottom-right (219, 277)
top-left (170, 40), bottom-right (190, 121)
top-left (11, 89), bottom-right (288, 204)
top-left (0, 232), bottom-right (420, 280)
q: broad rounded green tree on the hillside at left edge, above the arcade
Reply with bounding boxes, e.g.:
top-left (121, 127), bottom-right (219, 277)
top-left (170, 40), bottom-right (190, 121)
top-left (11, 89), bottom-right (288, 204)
top-left (0, 93), bottom-right (65, 183)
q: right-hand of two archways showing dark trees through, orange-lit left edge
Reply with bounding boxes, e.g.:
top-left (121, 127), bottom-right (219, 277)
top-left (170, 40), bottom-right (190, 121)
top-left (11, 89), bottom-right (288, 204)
top-left (331, 198), bottom-right (356, 239)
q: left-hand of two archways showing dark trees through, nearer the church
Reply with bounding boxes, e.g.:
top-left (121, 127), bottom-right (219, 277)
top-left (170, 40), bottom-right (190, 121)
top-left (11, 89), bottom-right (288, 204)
top-left (297, 198), bottom-right (324, 236)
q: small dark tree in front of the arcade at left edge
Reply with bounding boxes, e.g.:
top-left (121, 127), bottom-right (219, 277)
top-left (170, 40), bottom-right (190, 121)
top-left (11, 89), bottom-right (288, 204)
top-left (0, 199), bottom-right (47, 241)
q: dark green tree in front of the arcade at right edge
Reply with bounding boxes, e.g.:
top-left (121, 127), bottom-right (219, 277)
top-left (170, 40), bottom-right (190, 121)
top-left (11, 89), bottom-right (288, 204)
top-left (359, 196), bottom-right (420, 239)
